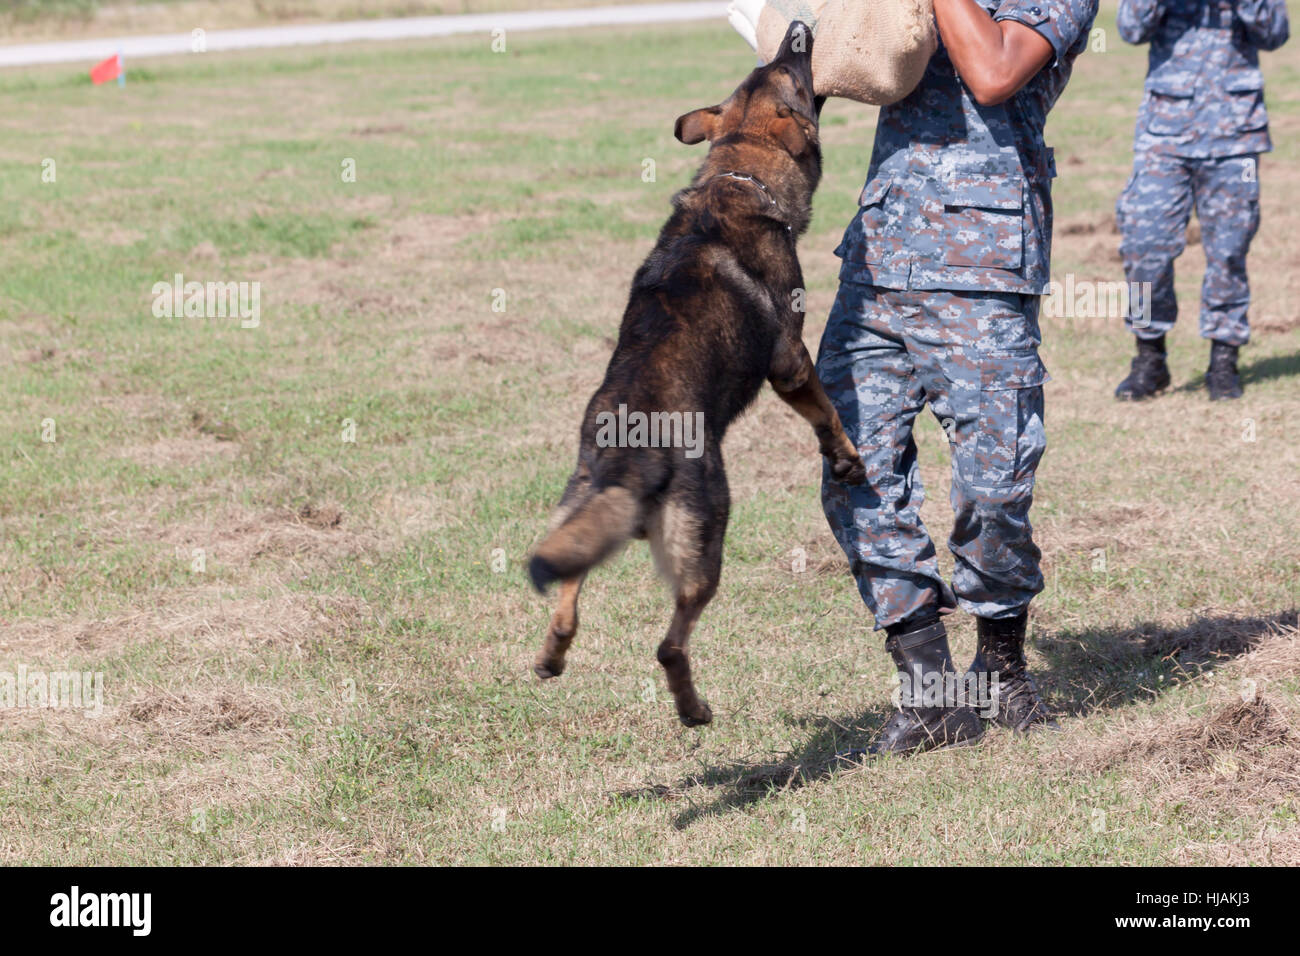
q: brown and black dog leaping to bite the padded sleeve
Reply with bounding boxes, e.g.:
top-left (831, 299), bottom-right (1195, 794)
top-left (528, 21), bottom-right (866, 727)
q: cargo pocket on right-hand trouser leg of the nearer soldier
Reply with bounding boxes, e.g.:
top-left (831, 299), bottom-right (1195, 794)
top-left (970, 349), bottom-right (1050, 488)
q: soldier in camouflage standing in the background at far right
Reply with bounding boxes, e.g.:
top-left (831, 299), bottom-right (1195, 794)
top-left (1115, 0), bottom-right (1290, 401)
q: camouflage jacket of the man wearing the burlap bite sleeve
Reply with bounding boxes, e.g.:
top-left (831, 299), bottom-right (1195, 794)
top-left (836, 0), bottom-right (1097, 295)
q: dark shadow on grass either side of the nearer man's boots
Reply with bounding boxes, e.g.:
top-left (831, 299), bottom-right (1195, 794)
top-left (618, 609), bottom-right (1297, 830)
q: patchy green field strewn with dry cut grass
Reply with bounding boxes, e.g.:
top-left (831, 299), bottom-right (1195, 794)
top-left (0, 5), bottom-right (1300, 865)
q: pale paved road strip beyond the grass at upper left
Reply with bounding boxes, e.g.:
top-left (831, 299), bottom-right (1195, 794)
top-left (0, 0), bottom-right (727, 66)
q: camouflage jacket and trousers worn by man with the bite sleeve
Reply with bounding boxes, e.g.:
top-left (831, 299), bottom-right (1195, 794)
top-left (818, 0), bottom-right (1097, 627)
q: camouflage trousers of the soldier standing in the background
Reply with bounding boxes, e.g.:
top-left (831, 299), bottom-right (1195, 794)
top-left (1115, 152), bottom-right (1260, 345)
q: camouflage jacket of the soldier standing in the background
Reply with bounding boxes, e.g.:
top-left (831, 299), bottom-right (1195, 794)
top-left (1118, 0), bottom-right (1290, 159)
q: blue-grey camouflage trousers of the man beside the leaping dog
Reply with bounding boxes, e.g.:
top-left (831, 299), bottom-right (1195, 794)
top-left (816, 282), bottom-right (1048, 628)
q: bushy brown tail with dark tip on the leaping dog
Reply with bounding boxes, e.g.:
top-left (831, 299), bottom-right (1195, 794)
top-left (528, 485), bottom-right (641, 592)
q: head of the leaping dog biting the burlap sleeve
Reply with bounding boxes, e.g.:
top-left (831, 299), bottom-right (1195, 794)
top-left (675, 21), bottom-right (822, 227)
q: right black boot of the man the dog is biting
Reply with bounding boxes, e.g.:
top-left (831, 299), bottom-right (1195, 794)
top-left (966, 611), bottom-right (1061, 734)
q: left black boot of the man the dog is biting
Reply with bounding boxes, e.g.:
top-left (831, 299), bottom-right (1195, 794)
top-left (846, 617), bottom-right (984, 758)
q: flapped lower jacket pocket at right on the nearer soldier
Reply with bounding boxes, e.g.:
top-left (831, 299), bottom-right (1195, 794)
top-left (940, 174), bottom-right (1024, 269)
